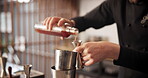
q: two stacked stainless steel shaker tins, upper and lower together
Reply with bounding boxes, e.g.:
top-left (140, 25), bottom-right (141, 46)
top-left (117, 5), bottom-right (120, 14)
top-left (51, 50), bottom-right (77, 78)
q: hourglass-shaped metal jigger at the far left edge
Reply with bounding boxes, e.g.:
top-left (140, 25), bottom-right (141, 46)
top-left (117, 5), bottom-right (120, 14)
top-left (0, 57), bottom-right (7, 78)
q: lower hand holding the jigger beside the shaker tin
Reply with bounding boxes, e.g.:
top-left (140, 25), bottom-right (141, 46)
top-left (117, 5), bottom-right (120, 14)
top-left (74, 41), bottom-right (120, 66)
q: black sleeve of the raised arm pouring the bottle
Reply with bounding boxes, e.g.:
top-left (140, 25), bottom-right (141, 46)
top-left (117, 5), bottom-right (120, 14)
top-left (72, 0), bottom-right (114, 32)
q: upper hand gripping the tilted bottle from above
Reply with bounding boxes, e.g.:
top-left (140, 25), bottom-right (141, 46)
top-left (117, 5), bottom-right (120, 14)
top-left (42, 17), bottom-right (75, 30)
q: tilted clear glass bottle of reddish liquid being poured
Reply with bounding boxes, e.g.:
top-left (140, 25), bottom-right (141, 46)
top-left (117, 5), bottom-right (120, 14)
top-left (34, 24), bottom-right (79, 37)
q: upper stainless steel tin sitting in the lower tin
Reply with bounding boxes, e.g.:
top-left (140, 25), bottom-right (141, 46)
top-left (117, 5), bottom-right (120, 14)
top-left (55, 50), bottom-right (77, 70)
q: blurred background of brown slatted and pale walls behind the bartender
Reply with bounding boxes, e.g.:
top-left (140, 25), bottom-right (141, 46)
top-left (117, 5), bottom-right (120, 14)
top-left (0, 0), bottom-right (118, 78)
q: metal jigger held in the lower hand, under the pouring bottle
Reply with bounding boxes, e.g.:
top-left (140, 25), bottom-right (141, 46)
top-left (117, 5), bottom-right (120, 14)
top-left (72, 40), bottom-right (84, 70)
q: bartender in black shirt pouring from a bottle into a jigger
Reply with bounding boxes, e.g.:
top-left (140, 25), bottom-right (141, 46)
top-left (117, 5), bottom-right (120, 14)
top-left (43, 0), bottom-right (148, 78)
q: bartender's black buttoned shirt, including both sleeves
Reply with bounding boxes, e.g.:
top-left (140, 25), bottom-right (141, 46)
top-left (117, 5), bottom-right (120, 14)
top-left (73, 0), bottom-right (148, 76)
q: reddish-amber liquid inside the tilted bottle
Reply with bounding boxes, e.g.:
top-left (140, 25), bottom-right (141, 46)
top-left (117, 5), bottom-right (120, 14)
top-left (35, 29), bottom-right (77, 37)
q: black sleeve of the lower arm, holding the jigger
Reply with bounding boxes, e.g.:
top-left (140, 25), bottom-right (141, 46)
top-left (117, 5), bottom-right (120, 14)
top-left (114, 46), bottom-right (148, 73)
